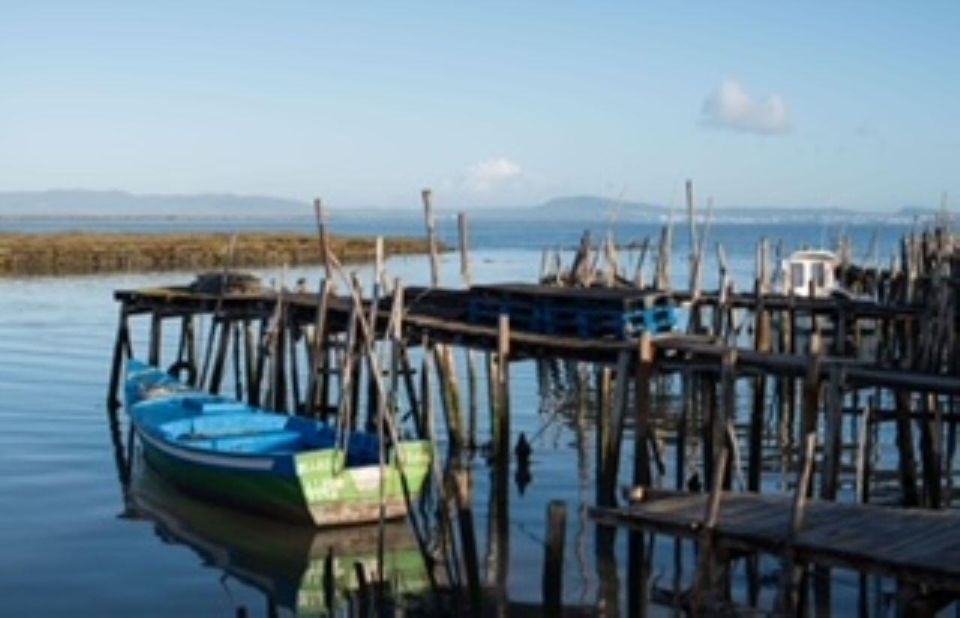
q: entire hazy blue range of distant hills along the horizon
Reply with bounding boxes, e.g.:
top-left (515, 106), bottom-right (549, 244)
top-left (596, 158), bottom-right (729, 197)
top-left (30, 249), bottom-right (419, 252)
top-left (0, 190), bottom-right (937, 223)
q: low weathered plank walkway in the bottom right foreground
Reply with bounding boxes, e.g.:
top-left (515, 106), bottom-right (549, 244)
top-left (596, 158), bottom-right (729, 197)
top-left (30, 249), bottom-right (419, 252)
top-left (591, 492), bottom-right (960, 594)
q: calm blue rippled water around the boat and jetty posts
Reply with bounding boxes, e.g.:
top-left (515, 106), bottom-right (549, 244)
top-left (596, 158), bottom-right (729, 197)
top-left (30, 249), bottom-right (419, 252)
top-left (0, 221), bottom-right (920, 616)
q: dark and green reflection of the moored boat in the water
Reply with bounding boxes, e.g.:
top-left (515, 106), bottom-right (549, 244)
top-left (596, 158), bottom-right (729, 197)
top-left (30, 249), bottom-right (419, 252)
top-left (126, 465), bottom-right (429, 616)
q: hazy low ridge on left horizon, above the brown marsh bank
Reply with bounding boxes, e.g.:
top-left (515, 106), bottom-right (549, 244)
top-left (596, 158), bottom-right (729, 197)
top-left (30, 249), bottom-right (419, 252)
top-left (0, 189), bottom-right (311, 217)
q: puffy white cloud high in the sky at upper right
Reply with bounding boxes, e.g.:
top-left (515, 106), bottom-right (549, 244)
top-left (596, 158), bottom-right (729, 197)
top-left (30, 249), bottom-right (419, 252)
top-left (703, 79), bottom-right (790, 135)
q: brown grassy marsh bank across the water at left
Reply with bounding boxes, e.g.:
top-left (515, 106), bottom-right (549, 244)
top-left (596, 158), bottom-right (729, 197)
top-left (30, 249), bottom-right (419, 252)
top-left (0, 232), bottom-right (445, 277)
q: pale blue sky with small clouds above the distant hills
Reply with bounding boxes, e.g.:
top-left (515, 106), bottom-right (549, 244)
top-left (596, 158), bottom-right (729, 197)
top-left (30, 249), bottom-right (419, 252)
top-left (0, 0), bottom-right (960, 211)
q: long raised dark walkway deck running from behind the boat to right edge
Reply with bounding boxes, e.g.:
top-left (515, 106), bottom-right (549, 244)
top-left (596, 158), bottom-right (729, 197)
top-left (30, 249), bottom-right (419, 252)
top-left (114, 287), bottom-right (960, 395)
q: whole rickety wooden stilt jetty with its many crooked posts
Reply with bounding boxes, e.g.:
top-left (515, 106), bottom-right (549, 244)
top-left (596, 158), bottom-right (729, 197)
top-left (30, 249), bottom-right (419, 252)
top-left (108, 186), bottom-right (960, 615)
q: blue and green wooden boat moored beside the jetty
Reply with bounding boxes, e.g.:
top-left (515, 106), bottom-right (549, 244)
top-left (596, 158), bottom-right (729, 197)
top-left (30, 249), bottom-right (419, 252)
top-left (125, 360), bottom-right (432, 527)
